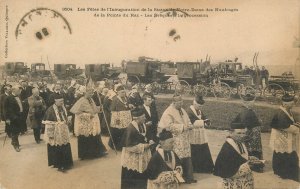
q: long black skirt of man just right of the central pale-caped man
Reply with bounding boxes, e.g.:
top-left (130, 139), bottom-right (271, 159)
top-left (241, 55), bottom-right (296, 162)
top-left (191, 143), bottom-right (214, 173)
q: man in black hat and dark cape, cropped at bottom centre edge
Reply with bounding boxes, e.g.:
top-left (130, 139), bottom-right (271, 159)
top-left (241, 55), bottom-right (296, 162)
top-left (145, 130), bottom-right (184, 189)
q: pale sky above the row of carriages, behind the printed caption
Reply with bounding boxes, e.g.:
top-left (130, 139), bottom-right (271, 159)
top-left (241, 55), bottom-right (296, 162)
top-left (0, 0), bottom-right (300, 68)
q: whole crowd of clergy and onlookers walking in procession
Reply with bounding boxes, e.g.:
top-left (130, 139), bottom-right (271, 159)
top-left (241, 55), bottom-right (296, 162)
top-left (0, 79), bottom-right (300, 189)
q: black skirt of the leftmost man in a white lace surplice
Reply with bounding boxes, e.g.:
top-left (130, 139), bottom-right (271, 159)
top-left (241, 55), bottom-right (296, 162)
top-left (47, 143), bottom-right (73, 169)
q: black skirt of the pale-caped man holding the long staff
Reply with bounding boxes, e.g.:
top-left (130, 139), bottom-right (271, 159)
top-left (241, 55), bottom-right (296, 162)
top-left (78, 135), bottom-right (106, 159)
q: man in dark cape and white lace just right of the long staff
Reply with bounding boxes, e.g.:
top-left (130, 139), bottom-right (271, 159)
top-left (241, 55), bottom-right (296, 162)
top-left (108, 85), bottom-right (132, 150)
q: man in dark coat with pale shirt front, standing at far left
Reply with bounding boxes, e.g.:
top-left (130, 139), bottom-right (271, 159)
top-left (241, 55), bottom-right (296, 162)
top-left (4, 85), bottom-right (26, 152)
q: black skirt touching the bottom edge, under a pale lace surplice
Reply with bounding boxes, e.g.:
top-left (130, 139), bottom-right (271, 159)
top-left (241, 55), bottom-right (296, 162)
top-left (121, 167), bottom-right (147, 189)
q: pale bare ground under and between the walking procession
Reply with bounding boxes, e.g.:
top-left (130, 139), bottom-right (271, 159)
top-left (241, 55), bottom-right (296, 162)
top-left (0, 127), bottom-right (299, 189)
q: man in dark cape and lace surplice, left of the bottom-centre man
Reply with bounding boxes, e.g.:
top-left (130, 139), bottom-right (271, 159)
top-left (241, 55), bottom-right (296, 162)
top-left (121, 109), bottom-right (151, 189)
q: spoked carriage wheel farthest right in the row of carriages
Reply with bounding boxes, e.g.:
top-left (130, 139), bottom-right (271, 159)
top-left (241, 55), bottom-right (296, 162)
top-left (263, 83), bottom-right (285, 104)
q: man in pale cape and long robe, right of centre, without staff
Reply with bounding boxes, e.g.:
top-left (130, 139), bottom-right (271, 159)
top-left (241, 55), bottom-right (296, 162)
top-left (158, 94), bottom-right (197, 184)
